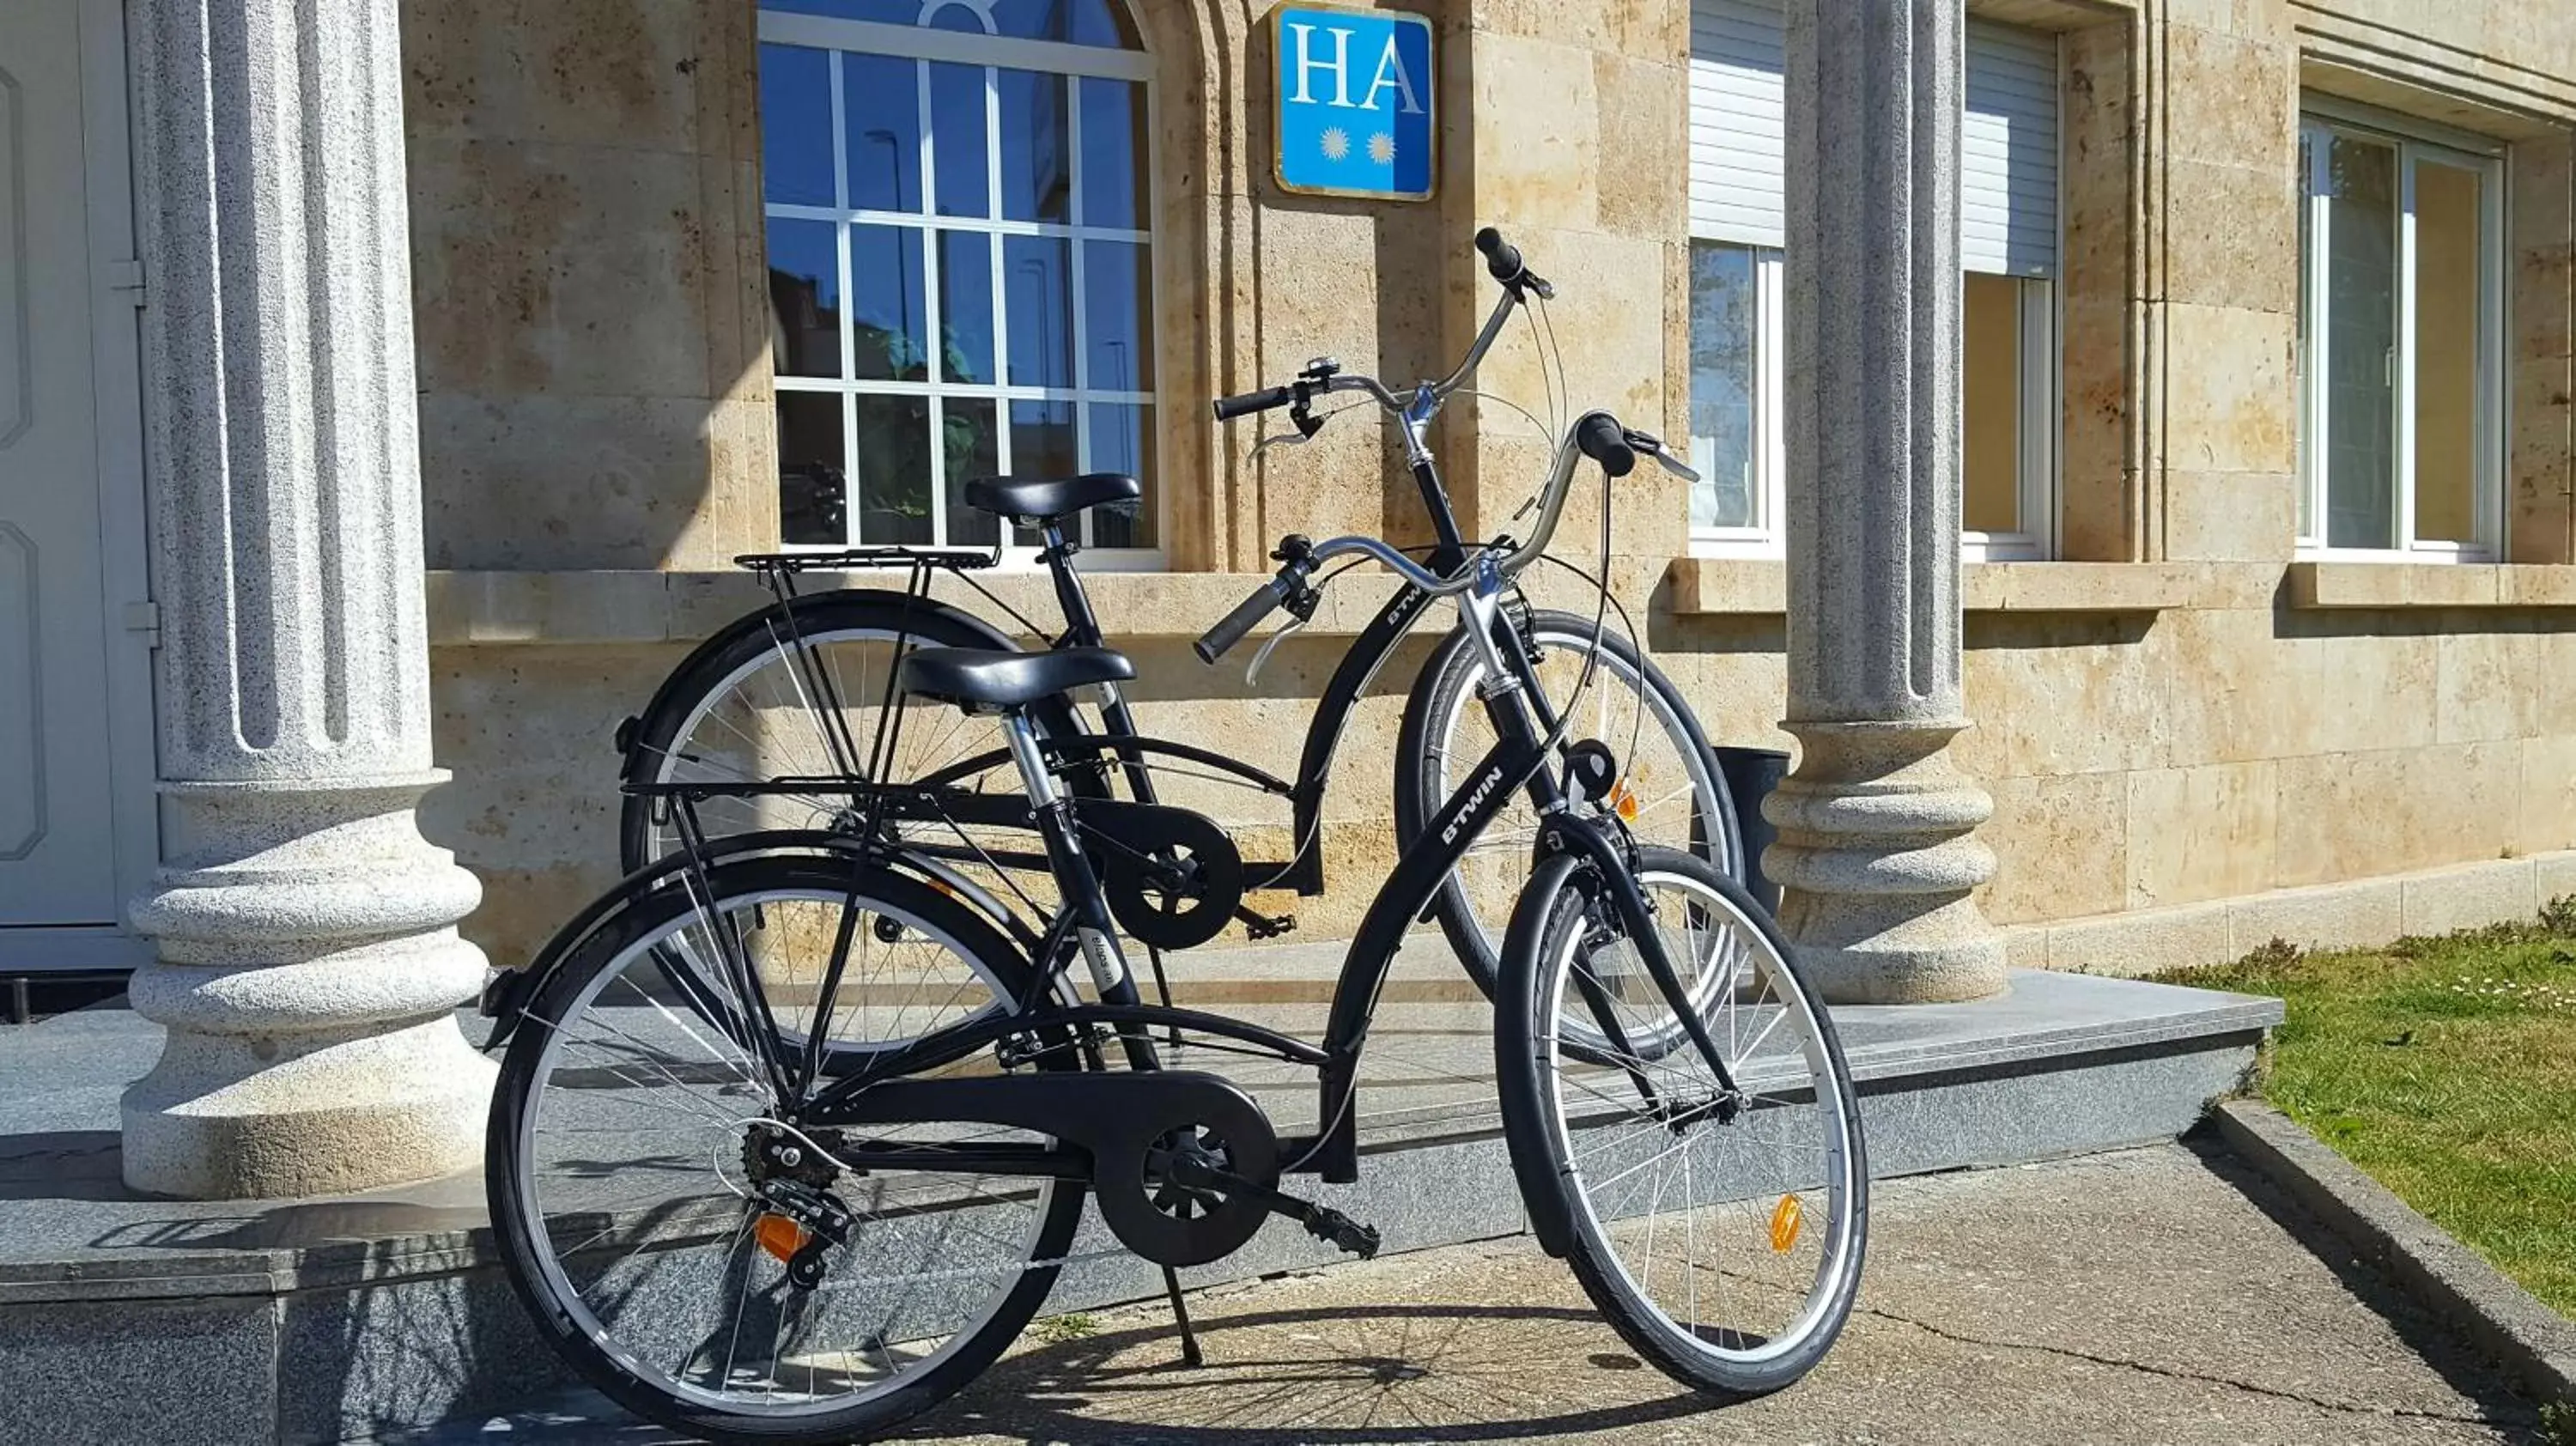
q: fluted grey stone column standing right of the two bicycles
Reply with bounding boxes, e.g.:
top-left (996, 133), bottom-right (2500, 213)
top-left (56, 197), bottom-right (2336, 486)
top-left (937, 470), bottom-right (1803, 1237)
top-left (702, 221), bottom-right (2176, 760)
top-left (1765, 0), bottom-right (2004, 1003)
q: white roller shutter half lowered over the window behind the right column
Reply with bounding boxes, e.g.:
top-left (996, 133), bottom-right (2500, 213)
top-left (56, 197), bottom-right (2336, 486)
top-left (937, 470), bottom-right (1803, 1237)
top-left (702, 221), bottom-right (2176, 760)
top-left (1690, 0), bottom-right (2058, 276)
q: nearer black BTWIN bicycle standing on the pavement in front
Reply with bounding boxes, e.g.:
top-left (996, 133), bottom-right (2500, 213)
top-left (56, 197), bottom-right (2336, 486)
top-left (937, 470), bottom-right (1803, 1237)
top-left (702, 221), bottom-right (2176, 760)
top-left (487, 230), bottom-right (1868, 1443)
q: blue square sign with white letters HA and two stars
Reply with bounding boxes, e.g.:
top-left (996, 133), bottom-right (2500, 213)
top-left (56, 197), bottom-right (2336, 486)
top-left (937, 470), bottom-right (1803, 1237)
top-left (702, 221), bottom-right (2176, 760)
top-left (1270, 5), bottom-right (1440, 201)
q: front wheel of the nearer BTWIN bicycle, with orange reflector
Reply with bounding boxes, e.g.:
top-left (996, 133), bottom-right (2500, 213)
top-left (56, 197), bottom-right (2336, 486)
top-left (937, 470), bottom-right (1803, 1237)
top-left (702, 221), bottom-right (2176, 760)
top-left (1497, 848), bottom-right (1870, 1397)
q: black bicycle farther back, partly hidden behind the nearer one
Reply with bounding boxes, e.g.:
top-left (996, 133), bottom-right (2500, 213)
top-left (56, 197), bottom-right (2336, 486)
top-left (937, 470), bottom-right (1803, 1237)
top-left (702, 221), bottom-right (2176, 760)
top-left (618, 229), bottom-right (1744, 995)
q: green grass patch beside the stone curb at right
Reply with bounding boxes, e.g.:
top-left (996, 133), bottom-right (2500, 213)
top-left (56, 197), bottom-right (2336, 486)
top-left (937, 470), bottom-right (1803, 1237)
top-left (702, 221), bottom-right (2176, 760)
top-left (2169, 900), bottom-right (2576, 1315)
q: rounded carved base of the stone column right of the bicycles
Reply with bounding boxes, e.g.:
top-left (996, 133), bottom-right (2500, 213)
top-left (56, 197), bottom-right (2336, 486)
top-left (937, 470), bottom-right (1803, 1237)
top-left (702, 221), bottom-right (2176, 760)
top-left (1762, 721), bottom-right (2004, 1006)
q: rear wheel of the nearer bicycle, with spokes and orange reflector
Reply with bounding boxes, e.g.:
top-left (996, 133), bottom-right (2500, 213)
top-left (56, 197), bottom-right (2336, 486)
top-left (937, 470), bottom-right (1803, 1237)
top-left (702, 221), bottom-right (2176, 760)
top-left (487, 859), bottom-right (1082, 1443)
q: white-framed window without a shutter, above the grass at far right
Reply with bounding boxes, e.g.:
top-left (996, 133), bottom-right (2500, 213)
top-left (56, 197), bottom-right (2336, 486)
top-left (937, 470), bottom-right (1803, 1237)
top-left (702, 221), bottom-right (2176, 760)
top-left (2298, 100), bottom-right (2504, 551)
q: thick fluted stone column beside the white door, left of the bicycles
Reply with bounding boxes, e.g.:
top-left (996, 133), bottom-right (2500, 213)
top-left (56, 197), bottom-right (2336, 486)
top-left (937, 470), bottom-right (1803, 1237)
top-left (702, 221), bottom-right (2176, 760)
top-left (124, 0), bottom-right (492, 1199)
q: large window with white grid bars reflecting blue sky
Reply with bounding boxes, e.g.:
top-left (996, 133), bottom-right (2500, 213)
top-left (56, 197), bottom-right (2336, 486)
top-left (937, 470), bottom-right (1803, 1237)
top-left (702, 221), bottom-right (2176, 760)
top-left (760, 0), bottom-right (1157, 549)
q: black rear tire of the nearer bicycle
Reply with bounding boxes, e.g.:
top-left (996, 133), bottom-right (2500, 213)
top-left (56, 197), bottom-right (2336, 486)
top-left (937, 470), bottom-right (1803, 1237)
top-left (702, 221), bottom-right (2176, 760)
top-left (484, 856), bottom-right (1084, 1446)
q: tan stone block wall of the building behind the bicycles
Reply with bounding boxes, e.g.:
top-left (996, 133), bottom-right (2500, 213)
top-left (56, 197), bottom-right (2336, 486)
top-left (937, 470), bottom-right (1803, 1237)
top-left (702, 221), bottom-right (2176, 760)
top-left (404, 0), bottom-right (2576, 967)
